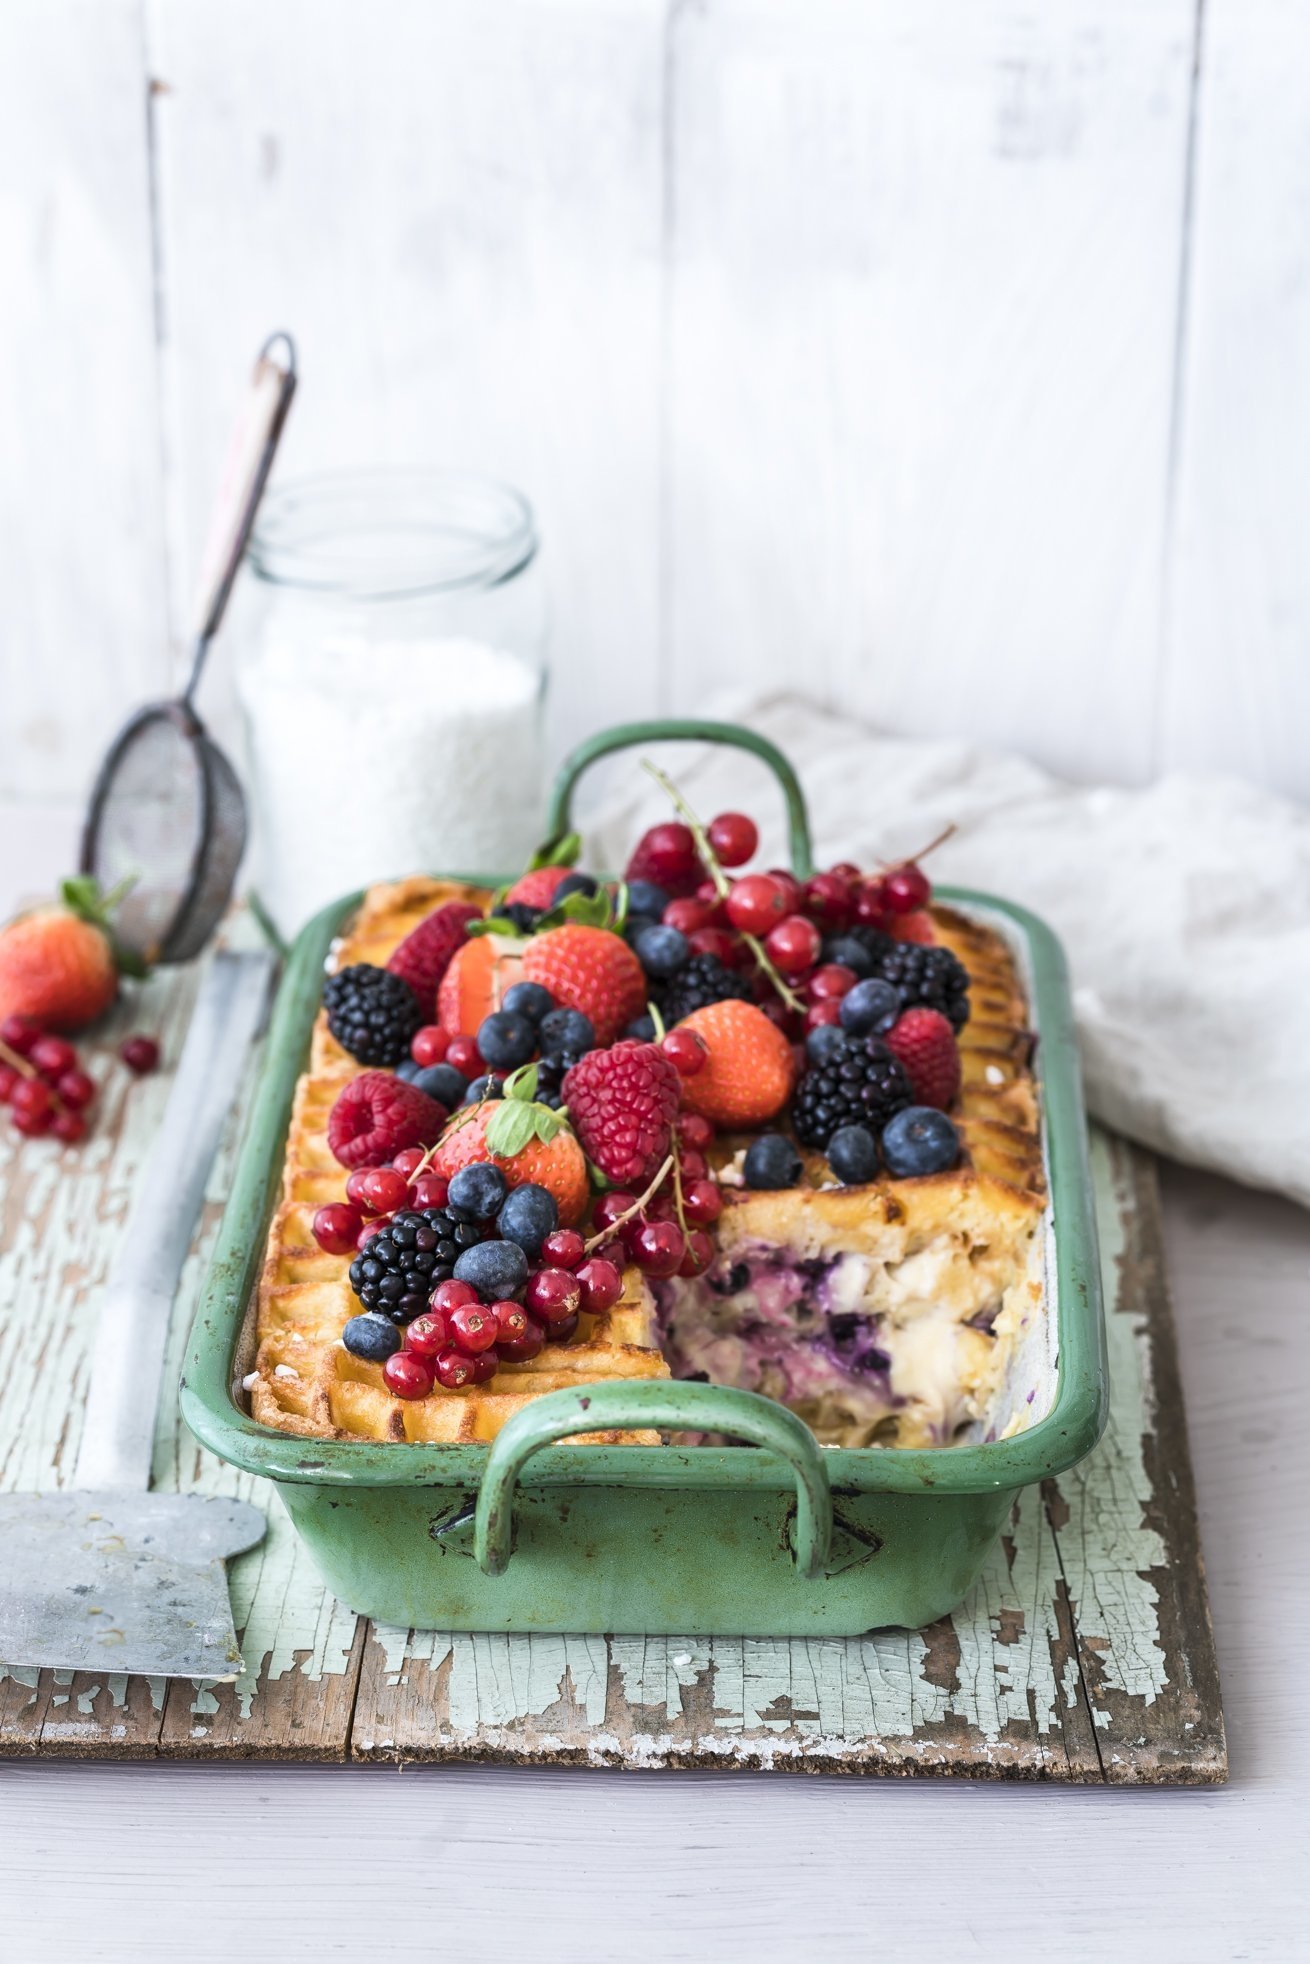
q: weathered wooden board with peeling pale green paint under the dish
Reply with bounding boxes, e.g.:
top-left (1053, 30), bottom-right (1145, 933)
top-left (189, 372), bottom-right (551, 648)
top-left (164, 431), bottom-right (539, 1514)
top-left (0, 980), bottom-right (1226, 1783)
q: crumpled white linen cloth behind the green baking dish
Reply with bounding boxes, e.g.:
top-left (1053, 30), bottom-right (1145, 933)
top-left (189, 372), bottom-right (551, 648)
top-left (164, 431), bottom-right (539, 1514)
top-left (585, 695), bottom-right (1310, 1206)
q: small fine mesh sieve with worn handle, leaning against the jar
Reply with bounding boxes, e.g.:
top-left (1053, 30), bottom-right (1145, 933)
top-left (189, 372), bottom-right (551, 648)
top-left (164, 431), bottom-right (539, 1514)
top-left (81, 334), bottom-right (297, 964)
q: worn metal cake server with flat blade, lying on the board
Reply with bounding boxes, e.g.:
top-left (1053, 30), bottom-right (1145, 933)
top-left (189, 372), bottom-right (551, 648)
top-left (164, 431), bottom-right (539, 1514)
top-left (0, 953), bottom-right (273, 1681)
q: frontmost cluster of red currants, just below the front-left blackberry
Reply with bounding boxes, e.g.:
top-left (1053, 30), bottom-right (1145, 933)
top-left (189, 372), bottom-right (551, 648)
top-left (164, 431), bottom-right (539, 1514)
top-left (383, 1228), bottom-right (623, 1398)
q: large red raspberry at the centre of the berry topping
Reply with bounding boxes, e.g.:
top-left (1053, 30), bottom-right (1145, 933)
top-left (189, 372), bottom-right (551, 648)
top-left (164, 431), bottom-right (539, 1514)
top-left (560, 1041), bottom-right (682, 1188)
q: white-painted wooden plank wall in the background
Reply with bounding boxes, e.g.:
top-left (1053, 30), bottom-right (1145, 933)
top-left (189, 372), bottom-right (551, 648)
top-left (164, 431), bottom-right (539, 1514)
top-left (0, 0), bottom-right (1310, 809)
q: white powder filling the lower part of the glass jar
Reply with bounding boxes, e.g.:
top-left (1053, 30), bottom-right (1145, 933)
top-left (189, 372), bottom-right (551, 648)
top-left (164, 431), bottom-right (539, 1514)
top-left (240, 636), bottom-right (542, 935)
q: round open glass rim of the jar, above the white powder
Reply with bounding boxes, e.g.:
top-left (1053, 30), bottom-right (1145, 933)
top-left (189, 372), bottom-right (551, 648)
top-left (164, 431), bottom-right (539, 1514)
top-left (247, 465), bottom-right (538, 601)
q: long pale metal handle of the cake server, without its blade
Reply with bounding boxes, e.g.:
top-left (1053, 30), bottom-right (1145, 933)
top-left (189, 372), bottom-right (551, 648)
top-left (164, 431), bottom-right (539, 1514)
top-left (73, 953), bottom-right (273, 1493)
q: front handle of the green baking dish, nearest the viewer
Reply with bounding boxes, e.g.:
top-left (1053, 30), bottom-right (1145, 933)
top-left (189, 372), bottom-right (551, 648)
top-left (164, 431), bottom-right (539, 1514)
top-left (473, 1379), bottom-right (833, 1581)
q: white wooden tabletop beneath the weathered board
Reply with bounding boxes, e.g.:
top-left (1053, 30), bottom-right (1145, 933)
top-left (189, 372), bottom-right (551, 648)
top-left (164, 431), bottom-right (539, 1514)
top-left (0, 813), bottom-right (1310, 1964)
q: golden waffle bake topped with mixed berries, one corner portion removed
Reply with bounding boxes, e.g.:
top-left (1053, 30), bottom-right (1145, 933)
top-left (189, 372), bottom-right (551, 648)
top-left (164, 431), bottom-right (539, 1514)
top-left (244, 819), bottom-right (1049, 1446)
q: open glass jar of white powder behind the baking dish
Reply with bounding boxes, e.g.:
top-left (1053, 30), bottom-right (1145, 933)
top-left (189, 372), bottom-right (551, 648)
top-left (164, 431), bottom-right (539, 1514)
top-left (238, 469), bottom-right (546, 937)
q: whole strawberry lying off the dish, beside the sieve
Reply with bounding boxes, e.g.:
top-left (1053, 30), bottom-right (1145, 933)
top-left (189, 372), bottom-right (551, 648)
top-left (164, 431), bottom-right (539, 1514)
top-left (0, 880), bottom-right (145, 1029)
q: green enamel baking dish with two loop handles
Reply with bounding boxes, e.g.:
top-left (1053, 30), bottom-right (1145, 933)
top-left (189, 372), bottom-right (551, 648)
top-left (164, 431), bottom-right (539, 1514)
top-left (181, 721), bottom-right (1108, 1636)
